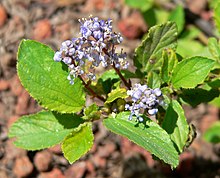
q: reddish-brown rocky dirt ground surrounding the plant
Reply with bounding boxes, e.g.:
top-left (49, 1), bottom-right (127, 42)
top-left (0, 0), bottom-right (220, 178)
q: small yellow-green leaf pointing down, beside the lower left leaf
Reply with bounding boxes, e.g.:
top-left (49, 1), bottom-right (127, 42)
top-left (62, 123), bottom-right (94, 164)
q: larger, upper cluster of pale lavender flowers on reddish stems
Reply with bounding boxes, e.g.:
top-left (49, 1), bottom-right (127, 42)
top-left (54, 17), bottom-right (129, 84)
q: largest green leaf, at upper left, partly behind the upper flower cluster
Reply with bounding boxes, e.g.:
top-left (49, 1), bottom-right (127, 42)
top-left (17, 40), bottom-right (85, 113)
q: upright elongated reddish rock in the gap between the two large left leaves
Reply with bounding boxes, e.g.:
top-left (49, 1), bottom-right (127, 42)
top-left (15, 90), bottom-right (30, 115)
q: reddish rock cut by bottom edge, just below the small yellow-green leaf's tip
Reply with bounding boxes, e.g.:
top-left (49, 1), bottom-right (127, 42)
top-left (65, 162), bottom-right (86, 178)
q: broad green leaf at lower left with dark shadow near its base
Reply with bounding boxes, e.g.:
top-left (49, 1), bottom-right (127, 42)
top-left (9, 111), bottom-right (83, 150)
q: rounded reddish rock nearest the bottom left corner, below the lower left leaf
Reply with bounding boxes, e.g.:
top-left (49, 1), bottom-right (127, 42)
top-left (13, 156), bottom-right (34, 178)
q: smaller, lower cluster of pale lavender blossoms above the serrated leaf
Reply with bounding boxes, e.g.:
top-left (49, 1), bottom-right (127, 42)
top-left (125, 84), bottom-right (163, 122)
